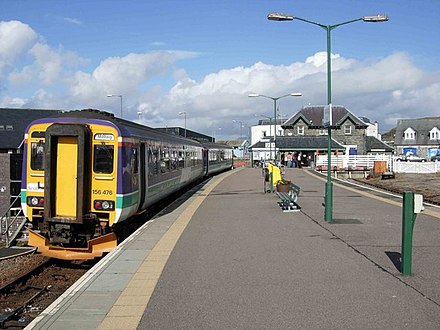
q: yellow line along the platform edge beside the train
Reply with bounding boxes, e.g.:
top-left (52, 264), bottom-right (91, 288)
top-left (98, 170), bottom-right (237, 330)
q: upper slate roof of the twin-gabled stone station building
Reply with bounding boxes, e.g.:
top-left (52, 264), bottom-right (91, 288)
top-left (281, 105), bottom-right (368, 128)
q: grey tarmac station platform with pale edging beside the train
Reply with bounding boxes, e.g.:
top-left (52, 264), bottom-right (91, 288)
top-left (27, 168), bottom-right (440, 330)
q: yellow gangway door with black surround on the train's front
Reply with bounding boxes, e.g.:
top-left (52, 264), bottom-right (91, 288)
top-left (44, 124), bottom-right (91, 224)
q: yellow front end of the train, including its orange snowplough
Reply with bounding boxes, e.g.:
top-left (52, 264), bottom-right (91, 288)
top-left (22, 123), bottom-right (118, 259)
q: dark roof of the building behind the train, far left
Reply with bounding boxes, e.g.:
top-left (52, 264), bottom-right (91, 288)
top-left (0, 108), bottom-right (62, 150)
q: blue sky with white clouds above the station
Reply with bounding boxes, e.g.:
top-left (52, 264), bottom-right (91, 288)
top-left (0, 0), bottom-right (440, 140)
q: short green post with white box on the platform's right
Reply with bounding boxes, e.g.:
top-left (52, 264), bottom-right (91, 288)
top-left (401, 191), bottom-right (423, 276)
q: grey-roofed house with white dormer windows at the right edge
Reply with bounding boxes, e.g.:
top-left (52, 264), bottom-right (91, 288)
top-left (394, 117), bottom-right (440, 159)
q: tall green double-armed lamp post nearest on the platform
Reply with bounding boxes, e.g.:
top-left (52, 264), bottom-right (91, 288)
top-left (267, 13), bottom-right (388, 222)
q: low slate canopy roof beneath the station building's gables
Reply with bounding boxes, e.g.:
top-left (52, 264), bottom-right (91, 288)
top-left (249, 136), bottom-right (345, 151)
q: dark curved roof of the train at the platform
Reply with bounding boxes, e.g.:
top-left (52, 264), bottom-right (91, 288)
top-left (29, 109), bottom-right (205, 146)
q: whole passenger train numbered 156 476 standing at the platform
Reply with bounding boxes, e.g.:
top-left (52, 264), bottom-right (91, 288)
top-left (21, 109), bottom-right (233, 260)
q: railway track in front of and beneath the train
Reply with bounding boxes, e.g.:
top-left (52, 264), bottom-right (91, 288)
top-left (0, 180), bottom-right (206, 329)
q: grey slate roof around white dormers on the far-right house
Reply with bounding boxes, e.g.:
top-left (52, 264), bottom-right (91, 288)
top-left (394, 117), bottom-right (440, 146)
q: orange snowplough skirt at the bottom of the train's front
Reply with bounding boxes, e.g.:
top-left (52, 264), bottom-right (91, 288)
top-left (28, 229), bottom-right (117, 260)
